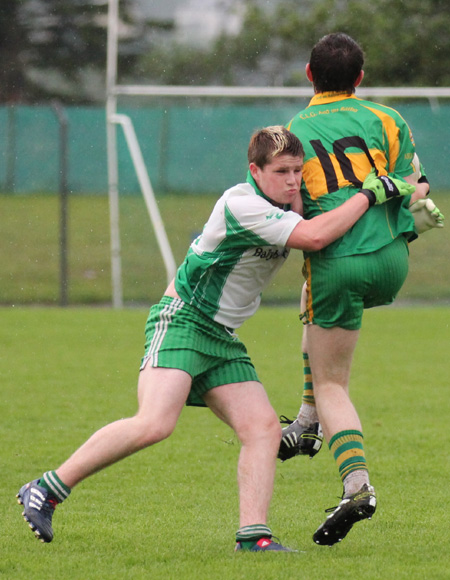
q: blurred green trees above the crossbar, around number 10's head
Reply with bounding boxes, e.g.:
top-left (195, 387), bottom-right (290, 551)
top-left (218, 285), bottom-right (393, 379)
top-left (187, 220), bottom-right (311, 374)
top-left (136, 0), bottom-right (450, 86)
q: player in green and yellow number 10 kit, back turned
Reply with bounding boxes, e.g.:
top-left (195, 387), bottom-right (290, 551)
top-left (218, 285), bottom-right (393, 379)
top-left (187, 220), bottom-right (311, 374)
top-left (279, 33), bottom-right (443, 545)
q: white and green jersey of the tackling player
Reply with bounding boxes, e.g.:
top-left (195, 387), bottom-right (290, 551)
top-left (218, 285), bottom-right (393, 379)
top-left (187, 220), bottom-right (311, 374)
top-left (176, 183), bottom-right (303, 328)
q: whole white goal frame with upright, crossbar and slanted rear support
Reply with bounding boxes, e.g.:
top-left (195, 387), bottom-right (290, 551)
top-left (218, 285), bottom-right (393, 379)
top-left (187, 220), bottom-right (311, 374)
top-left (106, 0), bottom-right (450, 308)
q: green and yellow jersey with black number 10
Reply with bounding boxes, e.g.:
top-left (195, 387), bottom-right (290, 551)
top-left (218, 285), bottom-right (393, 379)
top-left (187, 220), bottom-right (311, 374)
top-left (287, 92), bottom-right (415, 258)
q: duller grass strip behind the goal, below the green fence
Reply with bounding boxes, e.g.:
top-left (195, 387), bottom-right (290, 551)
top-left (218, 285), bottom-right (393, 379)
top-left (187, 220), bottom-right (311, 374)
top-left (0, 192), bottom-right (450, 305)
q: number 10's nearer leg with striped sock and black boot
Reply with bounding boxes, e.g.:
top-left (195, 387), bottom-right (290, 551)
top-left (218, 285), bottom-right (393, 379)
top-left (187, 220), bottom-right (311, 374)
top-left (308, 325), bottom-right (376, 546)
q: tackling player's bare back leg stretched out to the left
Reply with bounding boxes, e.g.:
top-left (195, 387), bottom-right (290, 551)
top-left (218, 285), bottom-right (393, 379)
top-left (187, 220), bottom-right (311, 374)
top-left (56, 365), bottom-right (191, 488)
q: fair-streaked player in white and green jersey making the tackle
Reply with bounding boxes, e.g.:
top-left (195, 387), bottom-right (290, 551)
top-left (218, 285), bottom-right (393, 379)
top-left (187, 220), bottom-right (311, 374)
top-left (17, 127), bottom-right (414, 551)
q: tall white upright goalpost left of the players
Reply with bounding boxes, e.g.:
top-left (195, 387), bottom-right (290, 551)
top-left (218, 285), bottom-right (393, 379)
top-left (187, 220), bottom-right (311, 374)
top-left (106, 0), bottom-right (123, 308)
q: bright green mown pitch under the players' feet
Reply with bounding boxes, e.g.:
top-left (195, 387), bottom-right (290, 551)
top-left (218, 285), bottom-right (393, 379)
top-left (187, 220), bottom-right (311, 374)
top-left (0, 307), bottom-right (450, 580)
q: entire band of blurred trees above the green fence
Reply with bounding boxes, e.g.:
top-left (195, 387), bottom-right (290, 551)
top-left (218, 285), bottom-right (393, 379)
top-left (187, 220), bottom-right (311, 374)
top-left (0, 0), bottom-right (450, 104)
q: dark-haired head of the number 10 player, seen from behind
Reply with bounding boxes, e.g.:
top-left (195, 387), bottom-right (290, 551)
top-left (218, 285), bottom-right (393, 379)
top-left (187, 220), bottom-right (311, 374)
top-left (309, 32), bottom-right (364, 93)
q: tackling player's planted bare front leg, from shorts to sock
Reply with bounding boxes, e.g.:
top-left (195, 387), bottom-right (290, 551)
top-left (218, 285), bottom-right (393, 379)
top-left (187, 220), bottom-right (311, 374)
top-left (205, 382), bottom-right (281, 527)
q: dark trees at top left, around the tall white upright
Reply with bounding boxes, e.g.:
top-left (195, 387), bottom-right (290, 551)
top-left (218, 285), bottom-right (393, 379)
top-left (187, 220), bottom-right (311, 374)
top-left (0, 0), bottom-right (173, 103)
